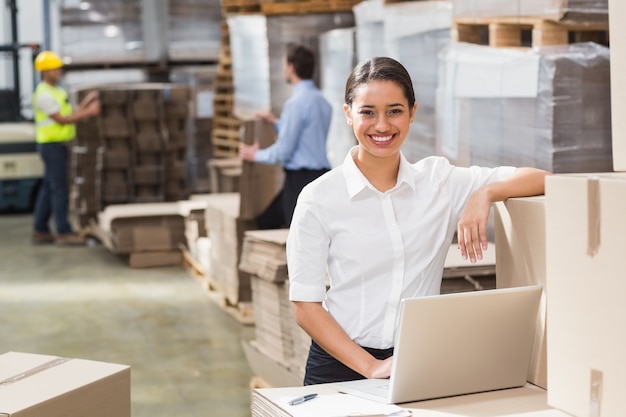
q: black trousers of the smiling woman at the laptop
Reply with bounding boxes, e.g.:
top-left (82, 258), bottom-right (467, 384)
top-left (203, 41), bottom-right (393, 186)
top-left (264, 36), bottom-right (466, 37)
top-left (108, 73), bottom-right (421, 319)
top-left (304, 342), bottom-right (393, 385)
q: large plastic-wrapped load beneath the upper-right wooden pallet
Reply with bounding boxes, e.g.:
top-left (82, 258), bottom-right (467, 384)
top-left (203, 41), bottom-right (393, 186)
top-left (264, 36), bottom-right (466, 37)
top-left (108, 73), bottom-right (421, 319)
top-left (437, 43), bottom-right (612, 173)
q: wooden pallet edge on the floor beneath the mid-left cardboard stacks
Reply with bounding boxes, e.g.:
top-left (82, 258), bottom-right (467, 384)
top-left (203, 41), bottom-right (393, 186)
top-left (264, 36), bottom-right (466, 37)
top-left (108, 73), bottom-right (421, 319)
top-left (181, 248), bottom-right (254, 326)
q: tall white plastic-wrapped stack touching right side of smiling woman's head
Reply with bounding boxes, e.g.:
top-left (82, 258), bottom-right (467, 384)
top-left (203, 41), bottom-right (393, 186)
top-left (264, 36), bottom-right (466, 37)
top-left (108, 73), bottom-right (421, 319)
top-left (383, 1), bottom-right (452, 161)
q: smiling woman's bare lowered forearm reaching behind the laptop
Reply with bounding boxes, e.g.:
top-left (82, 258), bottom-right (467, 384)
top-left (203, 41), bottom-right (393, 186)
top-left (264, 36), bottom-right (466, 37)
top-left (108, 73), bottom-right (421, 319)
top-left (292, 301), bottom-right (392, 378)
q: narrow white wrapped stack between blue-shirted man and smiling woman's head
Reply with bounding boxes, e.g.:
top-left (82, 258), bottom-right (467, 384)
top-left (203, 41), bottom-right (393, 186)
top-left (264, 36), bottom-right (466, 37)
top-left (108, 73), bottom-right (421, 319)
top-left (320, 28), bottom-right (356, 167)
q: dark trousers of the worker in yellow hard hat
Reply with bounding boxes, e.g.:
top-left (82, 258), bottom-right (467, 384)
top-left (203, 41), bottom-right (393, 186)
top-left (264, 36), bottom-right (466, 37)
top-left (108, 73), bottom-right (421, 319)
top-left (34, 142), bottom-right (72, 234)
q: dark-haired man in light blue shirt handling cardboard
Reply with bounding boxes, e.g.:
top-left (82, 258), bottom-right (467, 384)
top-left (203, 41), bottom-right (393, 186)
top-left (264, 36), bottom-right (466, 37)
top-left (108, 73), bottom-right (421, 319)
top-left (239, 44), bottom-right (332, 229)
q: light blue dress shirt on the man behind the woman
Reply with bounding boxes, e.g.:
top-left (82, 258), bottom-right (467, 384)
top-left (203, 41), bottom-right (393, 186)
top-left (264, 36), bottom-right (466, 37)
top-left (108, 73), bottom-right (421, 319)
top-left (254, 80), bottom-right (332, 170)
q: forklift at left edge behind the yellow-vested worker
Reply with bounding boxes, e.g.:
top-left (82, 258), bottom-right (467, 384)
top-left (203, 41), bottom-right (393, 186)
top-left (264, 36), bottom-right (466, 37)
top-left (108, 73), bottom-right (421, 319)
top-left (0, 0), bottom-right (44, 212)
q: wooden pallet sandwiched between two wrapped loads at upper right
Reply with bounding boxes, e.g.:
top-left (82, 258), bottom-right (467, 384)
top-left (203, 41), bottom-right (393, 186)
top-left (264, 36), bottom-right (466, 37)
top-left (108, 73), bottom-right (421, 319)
top-left (452, 17), bottom-right (609, 47)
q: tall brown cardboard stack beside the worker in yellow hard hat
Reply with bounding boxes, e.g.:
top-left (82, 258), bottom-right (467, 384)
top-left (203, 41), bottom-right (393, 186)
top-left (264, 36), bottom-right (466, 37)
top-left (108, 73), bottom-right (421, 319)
top-left (70, 84), bottom-right (191, 231)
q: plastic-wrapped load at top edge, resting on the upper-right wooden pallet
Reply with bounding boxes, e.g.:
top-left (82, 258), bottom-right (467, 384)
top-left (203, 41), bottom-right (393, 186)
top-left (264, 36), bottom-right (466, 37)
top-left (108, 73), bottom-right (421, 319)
top-left (453, 0), bottom-right (608, 22)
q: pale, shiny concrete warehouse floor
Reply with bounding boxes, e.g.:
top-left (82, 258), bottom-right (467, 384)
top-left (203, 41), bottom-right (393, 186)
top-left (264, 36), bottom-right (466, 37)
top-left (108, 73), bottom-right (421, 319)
top-left (0, 214), bottom-right (254, 417)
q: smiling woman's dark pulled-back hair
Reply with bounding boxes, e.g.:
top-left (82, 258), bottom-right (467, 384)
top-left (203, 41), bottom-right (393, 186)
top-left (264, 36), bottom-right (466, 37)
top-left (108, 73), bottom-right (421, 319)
top-left (345, 57), bottom-right (415, 109)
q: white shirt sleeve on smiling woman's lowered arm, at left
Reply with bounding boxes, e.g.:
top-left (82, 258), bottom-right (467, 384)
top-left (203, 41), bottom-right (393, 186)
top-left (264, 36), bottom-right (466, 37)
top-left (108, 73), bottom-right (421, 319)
top-left (287, 187), bottom-right (329, 302)
